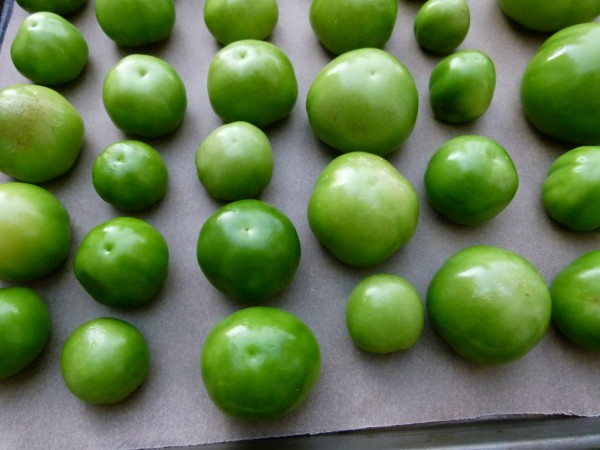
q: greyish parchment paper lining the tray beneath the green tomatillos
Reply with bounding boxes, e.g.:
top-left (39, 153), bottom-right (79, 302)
top-left (0, 0), bottom-right (600, 449)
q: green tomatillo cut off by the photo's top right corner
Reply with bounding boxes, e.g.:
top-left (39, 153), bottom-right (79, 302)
top-left (498, 0), bottom-right (600, 32)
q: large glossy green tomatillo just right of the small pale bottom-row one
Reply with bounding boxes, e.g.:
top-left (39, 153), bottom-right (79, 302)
top-left (427, 246), bottom-right (552, 364)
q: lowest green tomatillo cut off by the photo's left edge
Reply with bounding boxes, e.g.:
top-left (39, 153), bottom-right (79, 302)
top-left (0, 287), bottom-right (51, 379)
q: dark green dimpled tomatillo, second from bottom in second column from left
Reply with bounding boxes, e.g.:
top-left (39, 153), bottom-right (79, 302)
top-left (73, 217), bottom-right (169, 308)
